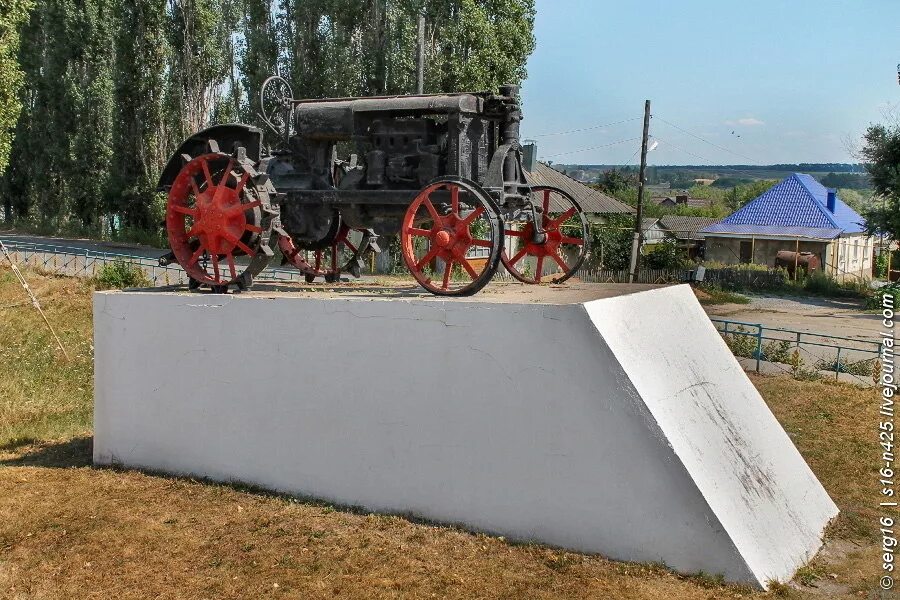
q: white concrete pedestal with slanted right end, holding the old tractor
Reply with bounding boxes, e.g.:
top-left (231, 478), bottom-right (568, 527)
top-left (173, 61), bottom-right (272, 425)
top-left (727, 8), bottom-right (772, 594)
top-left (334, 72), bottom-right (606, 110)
top-left (94, 284), bottom-right (838, 587)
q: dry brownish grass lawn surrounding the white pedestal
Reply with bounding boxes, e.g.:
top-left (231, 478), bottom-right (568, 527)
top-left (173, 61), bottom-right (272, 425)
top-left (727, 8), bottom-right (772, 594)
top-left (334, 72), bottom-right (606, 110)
top-left (0, 270), bottom-right (878, 600)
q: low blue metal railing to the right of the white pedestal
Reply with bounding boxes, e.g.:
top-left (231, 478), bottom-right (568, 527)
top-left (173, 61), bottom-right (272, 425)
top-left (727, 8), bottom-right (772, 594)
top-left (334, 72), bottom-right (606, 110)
top-left (710, 319), bottom-right (881, 385)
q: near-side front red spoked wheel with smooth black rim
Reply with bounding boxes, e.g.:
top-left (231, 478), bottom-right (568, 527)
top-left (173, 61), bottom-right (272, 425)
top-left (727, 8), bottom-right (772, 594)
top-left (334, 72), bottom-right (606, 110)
top-left (400, 177), bottom-right (503, 296)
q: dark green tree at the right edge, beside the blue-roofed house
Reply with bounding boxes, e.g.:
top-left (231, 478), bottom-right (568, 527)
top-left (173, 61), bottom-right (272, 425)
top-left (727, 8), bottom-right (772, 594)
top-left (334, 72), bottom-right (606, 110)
top-left (861, 125), bottom-right (900, 239)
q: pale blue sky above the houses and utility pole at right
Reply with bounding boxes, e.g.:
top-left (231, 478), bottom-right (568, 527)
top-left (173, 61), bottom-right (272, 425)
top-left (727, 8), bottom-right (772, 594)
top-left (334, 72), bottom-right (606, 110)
top-left (522, 0), bottom-right (900, 165)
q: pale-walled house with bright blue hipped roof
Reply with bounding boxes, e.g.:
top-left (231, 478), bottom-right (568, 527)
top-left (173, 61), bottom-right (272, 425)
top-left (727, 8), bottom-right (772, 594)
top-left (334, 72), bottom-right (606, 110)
top-left (701, 173), bottom-right (874, 279)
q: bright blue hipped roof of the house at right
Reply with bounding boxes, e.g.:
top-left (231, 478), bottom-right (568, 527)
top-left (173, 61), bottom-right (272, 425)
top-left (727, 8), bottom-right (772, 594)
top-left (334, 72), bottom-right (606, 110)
top-left (702, 173), bottom-right (866, 239)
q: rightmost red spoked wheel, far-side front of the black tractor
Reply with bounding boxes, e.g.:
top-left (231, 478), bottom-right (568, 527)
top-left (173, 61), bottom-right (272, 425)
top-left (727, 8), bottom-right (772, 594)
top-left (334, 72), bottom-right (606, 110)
top-left (502, 186), bottom-right (590, 283)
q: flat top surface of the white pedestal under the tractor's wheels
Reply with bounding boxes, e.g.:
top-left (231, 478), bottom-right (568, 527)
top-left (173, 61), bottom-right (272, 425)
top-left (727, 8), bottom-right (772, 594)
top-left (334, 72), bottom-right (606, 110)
top-left (105, 280), bottom-right (665, 305)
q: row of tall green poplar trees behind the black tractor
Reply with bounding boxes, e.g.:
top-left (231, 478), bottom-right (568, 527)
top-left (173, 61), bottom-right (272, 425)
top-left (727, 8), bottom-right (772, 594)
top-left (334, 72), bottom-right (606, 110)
top-left (0, 0), bottom-right (535, 239)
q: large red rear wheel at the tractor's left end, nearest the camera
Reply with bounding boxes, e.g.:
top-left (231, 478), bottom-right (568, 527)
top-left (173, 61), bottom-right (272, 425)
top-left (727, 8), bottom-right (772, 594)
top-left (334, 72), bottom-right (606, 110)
top-left (166, 152), bottom-right (271, 291)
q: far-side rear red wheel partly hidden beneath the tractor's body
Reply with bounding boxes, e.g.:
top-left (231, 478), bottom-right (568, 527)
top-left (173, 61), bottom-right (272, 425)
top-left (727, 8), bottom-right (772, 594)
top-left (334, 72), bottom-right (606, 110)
top-left (278, 224), bottom-right (375, 283)
